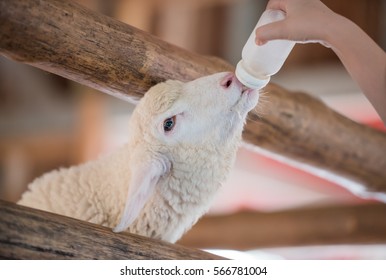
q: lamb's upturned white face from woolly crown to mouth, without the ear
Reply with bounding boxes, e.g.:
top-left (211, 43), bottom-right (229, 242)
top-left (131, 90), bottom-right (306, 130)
top-left (130, 73), bottom-right (259, 146)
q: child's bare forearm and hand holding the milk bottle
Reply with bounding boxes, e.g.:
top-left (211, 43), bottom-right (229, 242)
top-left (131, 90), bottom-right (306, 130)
top-left (255, 0), bottom-right (386, 124)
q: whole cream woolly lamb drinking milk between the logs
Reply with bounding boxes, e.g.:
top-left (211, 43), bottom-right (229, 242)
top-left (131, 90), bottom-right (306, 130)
top-left (18, 73), bottom-right (259, 242)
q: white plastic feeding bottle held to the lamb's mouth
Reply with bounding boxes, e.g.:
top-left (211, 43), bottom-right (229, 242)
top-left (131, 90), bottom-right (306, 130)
top-left (236, 10), bottom-right (295, 89)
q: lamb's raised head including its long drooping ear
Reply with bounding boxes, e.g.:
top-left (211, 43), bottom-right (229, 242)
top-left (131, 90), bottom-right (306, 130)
top-left (115, 72), bottom-right (259, 234)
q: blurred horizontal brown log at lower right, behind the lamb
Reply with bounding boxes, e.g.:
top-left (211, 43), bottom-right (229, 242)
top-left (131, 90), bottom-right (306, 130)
top-left (178, 204), bottom-right (386, 250)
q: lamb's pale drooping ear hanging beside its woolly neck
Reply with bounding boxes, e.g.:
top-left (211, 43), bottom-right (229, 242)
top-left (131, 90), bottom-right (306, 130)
top-left (113, 155), bottom-right (170, 232)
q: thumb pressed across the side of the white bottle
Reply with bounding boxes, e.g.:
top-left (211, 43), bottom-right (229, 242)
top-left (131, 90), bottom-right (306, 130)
top-left (255, 20), bottom-right (289, 45)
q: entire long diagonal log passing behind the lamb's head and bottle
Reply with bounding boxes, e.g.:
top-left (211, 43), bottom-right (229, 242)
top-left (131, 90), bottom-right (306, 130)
top-left (0, 0), bottom-right (386, 196)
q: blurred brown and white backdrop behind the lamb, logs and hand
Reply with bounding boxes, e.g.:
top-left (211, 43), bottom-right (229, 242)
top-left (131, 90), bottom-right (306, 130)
top-left (0, 0), bottom-right (386, 258)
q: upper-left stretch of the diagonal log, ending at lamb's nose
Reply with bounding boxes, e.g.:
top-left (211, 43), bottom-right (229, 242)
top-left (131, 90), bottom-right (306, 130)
top-left (0, 0), bottom-right (232, 100)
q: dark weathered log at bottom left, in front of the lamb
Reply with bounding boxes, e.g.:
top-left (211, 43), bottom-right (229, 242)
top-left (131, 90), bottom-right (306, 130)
top-left (0, 200), bottom-right (221, 260)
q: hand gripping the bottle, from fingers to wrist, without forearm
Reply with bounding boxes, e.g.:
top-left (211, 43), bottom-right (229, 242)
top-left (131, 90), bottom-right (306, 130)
top-left (255, 0), bottom-right (340, 46)
